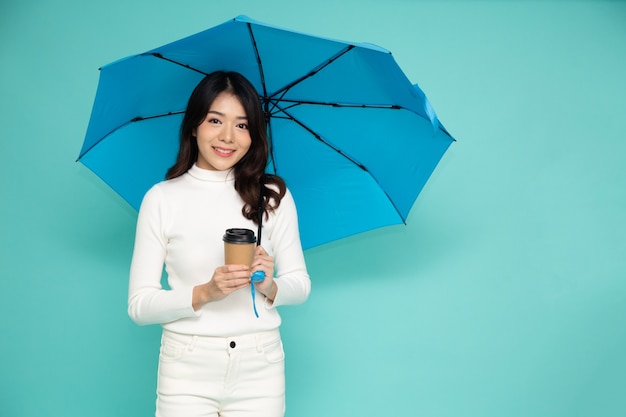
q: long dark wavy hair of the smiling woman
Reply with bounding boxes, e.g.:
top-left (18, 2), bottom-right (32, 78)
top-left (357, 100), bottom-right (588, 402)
top-left (165, 71), bottom-right (286, 224)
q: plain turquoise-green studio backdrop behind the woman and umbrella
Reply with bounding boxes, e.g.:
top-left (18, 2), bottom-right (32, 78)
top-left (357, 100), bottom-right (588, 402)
top-left (0, 0), bottom-right (626, 417)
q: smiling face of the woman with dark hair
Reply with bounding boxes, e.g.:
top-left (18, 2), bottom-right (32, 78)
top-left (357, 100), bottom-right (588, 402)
top-left (193, 92), bottom-right (252, 171)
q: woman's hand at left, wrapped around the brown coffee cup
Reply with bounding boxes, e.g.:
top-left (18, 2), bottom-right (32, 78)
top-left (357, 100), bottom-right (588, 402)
top-left (192, 265), bottom-right (250, 311)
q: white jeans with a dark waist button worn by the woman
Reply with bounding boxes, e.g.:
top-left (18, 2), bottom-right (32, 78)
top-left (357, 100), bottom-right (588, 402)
top-left (156, 330), bottom-right (285, 417)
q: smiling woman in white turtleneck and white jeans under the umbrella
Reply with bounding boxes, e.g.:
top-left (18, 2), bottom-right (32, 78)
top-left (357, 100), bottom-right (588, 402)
top-left (128, 72), bottom-right (310, 417)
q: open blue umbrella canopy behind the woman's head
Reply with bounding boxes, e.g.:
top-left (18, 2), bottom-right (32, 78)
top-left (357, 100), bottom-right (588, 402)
top-left (78, 16), bottom-right (454, 248)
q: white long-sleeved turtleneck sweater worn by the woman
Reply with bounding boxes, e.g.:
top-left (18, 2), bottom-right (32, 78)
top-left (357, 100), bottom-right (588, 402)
top-left (128, 165), bottom-right (311, 336)
